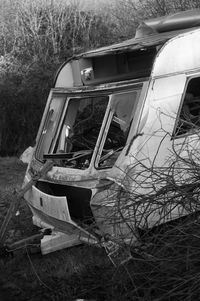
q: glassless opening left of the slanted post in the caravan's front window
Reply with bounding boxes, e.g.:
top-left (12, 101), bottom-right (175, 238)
top-left (53, 96), bottom-right (109, 168)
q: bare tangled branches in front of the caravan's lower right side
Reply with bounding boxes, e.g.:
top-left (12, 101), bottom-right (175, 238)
top-left (92, 128), bottom-right (200, 300)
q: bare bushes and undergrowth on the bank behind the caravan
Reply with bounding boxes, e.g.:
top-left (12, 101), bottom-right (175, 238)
top-left (0, 0), bottom-right (200, 156)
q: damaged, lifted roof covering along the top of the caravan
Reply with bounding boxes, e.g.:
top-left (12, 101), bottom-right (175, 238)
top-left (75, 9), bottom-right (200, 58)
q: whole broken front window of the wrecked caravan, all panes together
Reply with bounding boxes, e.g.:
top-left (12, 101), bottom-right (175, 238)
top-left (36, 85), bottom-right (142, 169)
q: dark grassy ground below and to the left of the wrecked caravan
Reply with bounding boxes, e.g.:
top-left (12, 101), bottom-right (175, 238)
top-left (0, 158), bottom-right (200, 301)
